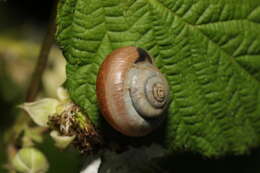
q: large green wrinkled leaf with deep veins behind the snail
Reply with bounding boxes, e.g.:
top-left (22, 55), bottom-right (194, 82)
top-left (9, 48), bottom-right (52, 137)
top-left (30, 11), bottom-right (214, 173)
top-left (57, 0), bottom-right (260, 156)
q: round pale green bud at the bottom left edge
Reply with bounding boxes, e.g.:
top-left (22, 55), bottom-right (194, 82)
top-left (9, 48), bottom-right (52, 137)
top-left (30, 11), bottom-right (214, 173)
top-left (12, 148), bottom-right (49, 173)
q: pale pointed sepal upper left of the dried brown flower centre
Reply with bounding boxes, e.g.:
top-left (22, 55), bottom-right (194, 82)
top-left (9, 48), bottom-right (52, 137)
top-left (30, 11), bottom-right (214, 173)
top-left (19, 98), bottom-right (59, 127)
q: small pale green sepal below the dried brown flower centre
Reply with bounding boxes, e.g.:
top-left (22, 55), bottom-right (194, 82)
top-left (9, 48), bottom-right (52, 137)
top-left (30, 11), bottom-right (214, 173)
top-left (50, 130), bottom-right (75, 149)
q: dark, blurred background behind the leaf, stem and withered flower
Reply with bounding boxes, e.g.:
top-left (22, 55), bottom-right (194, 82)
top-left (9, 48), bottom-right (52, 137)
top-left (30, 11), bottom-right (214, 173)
top-left (0, 0), bottom-right (260, 173)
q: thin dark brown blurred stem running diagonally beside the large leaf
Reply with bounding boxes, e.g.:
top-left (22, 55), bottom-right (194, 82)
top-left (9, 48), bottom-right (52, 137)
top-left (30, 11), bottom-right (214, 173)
top-left (26, 0), bottom-right (58, 102)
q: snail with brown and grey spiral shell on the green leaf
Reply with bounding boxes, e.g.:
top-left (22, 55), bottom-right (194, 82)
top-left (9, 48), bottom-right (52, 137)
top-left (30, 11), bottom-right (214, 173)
top-left (96, 47), bottom-right (169, 136)
